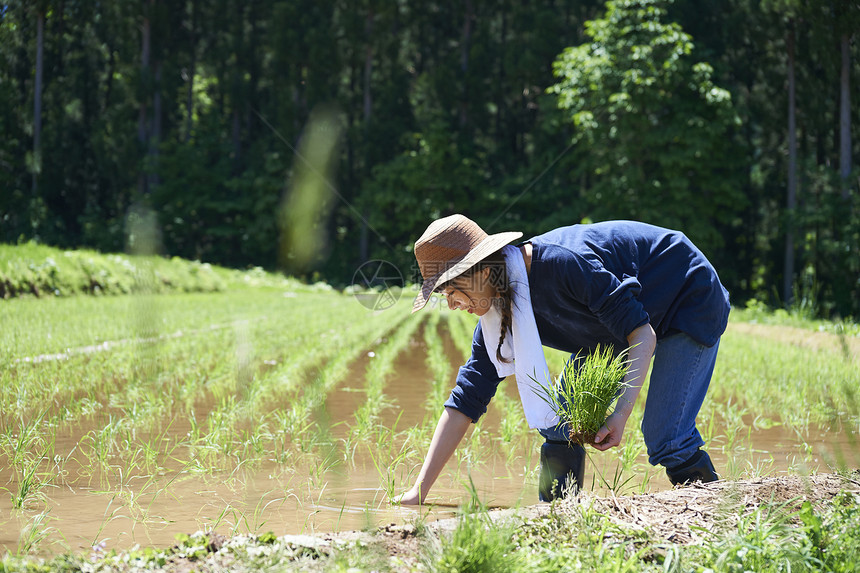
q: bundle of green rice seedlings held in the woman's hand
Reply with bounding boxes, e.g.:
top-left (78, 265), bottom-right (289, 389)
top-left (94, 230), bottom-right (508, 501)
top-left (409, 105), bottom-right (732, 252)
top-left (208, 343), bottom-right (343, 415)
top-left (538, 345), bottom-right (630, 445)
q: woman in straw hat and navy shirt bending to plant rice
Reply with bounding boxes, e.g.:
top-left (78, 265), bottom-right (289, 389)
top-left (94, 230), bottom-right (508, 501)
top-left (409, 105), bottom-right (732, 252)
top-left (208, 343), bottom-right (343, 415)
top-left (398, 215), bottom-right (729, 505)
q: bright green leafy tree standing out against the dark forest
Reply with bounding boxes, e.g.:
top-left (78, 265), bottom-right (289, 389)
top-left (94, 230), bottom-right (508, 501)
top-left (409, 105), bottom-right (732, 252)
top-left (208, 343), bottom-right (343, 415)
top-left (553, 0), bottom-right (744, 251)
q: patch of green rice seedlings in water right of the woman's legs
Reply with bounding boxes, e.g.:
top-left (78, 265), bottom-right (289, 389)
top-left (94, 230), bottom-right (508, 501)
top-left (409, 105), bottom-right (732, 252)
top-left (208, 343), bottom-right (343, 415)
top-left (705, 324), bottom-right (860, 477)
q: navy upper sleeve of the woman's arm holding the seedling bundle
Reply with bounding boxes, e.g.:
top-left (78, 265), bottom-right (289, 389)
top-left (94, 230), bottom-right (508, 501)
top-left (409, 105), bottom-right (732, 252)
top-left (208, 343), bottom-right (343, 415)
top-left (568, 260), bottom-right (650, 340)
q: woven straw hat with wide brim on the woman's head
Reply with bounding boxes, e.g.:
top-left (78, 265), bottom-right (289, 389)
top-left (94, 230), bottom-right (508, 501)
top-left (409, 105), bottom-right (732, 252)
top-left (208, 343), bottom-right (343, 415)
top-left (412, 215), bottom-right (523, 312)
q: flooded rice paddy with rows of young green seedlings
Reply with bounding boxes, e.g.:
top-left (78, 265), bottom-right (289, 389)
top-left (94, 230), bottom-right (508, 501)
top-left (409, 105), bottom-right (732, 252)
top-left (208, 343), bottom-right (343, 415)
top-left (0, 292), bottom-right (860, 554)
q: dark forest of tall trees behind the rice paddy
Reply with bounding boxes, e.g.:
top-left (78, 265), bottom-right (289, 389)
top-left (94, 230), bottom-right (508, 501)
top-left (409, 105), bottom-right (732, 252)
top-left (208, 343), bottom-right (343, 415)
top-left (0, 0), bottom-right (860, 318)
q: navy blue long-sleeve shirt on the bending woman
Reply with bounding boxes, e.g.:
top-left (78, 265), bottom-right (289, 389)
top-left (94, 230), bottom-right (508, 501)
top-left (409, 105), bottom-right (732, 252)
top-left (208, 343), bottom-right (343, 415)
top-left (445, 221), bottom-right (730, 420)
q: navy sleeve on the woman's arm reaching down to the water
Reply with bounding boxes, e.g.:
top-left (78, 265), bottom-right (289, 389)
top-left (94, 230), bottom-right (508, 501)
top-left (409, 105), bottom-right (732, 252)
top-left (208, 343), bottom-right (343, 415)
top-left (445, 322), bottom-right (504, 422)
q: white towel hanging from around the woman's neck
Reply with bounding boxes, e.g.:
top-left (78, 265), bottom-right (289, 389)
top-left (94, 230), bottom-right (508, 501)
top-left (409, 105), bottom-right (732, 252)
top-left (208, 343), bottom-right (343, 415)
top-left (481, 245), bottom-right (559, 428)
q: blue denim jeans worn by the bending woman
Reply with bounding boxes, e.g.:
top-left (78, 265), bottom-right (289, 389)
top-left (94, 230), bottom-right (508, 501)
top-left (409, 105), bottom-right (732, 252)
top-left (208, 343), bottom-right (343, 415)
top-left (539, 333), bottom-right (720, 468)
